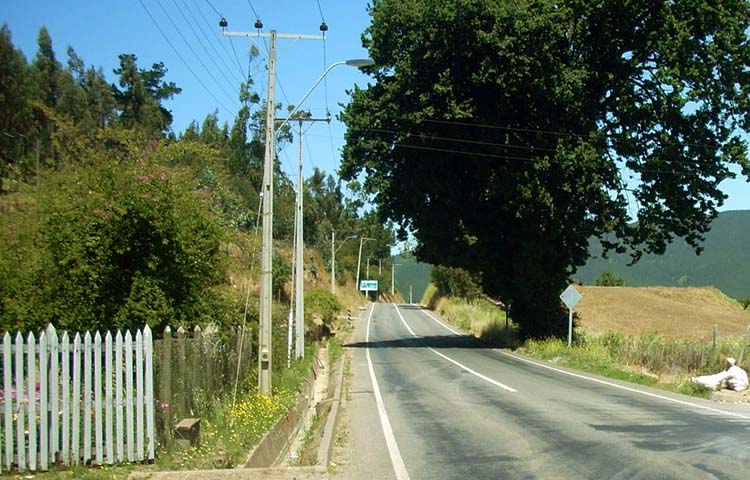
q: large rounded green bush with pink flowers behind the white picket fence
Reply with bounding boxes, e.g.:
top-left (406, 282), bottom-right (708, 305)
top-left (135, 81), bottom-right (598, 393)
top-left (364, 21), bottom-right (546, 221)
top-left (0, 155), bottom-right (227, 331)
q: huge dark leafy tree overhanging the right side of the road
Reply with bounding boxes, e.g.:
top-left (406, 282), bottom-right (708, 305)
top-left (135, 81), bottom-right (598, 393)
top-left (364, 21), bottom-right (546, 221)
top-left (342, 0), bottom-right (750, 336)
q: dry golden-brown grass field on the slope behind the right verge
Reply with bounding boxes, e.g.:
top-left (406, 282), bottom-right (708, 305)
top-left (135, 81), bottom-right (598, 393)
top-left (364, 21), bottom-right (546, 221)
top-left (575, 286), bottom-right (750, 340)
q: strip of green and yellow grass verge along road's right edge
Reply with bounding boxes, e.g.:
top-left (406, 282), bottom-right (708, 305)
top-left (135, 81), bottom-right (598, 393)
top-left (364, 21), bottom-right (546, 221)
top-left (422, 272), bottom-right (750, 398)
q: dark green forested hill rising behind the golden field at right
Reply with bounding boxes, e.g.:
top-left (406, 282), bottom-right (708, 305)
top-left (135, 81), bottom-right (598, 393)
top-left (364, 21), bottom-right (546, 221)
top-left (574, 210), bottom-right (750, 298)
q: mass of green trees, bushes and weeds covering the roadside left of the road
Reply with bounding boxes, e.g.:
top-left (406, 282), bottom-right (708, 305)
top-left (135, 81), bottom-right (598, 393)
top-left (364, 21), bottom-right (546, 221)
top-left (0, 25), bottom-right (393, 478)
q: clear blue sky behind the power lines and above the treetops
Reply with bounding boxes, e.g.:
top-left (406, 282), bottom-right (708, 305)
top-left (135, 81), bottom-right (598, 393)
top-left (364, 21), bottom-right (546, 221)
top-left (0, 0), bottom-right (750, 210)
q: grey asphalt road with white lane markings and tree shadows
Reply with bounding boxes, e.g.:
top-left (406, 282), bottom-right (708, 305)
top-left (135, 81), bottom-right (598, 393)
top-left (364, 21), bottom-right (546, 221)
top-left (336, 304), bottom-right (750, 480)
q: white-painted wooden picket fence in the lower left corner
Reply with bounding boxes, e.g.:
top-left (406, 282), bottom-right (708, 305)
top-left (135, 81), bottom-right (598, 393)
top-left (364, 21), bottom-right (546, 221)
top-left (0, 325), bottom-right (156, 471)
